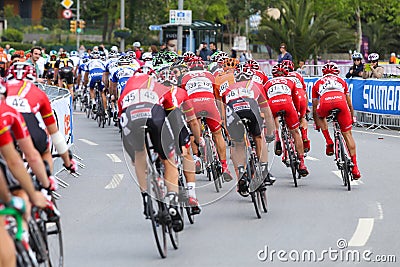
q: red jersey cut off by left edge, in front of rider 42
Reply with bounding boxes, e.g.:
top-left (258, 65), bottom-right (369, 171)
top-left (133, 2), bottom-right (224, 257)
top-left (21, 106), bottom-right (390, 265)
top-left (0, 100), bottom-right (29, 146)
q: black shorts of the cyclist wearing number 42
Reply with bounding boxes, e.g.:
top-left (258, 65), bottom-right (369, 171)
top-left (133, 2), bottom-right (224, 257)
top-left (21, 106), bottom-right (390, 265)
top-left (21, 113), bottom-right (49, 155)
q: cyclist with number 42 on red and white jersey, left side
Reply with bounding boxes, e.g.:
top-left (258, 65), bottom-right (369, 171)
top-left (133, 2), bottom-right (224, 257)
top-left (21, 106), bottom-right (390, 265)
top-left (6, 63), bottom-right (77, 176)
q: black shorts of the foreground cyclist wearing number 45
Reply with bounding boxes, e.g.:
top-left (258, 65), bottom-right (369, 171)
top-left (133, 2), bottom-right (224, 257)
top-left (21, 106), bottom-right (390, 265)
top-left (120, 103), bottom-right (175, 161)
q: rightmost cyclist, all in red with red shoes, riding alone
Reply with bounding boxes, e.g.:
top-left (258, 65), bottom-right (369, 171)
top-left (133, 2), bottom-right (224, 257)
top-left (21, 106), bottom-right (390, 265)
top-left (312, 62), bottom-right (361, 179)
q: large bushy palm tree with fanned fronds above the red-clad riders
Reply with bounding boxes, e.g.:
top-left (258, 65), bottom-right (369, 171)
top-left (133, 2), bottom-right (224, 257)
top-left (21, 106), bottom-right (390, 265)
top-left (259, 0), bottom-right (354, 62)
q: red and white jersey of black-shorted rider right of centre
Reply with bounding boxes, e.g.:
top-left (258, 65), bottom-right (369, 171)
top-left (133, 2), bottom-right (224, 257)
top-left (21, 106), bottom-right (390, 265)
top-left (222, 80), bottom-right (268, 108)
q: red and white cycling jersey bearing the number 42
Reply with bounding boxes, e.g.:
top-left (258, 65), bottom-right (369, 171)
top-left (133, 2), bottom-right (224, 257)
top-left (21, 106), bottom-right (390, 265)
top-left (6, 80), bottom-right (56, 126)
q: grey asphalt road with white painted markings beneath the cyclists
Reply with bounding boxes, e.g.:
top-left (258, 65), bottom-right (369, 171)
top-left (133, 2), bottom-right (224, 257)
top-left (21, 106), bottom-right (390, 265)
top-left (55, 112), bottom-right (400, 267)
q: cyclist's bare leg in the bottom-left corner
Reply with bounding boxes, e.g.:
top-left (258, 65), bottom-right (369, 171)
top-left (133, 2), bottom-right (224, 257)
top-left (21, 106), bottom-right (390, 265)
top-left (0, 219), bottom-right (16, 267)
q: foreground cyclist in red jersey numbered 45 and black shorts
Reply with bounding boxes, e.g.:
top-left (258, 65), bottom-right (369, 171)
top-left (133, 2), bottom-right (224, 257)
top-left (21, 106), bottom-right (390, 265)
top-left (118, 69), bottom-right (183, 232)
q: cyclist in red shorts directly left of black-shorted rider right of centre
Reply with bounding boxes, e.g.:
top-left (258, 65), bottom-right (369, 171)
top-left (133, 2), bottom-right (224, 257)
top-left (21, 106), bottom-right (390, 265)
top-left (182, 58), bottom-right (232, 182)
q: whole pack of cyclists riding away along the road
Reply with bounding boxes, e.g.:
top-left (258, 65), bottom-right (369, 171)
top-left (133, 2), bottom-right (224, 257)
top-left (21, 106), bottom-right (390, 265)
top-left (0, 46), bottom-right (361, 264)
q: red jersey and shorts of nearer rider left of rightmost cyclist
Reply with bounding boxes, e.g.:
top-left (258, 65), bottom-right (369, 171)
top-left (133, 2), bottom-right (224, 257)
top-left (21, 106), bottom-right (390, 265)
top-left (264, 77), bottom-right (300, 130)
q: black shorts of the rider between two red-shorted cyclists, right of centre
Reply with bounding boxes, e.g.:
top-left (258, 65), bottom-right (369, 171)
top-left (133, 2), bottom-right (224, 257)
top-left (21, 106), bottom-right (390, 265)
top-left (226, 98), bottom-right (263, 142)
